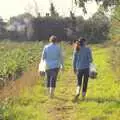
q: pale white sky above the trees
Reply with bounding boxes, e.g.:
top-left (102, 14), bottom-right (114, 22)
top-left (0, 0), bottom-right (98, 19)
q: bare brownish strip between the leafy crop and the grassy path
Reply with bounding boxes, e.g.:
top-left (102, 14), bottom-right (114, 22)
top-left (0, 64), bottom-right (38, 99)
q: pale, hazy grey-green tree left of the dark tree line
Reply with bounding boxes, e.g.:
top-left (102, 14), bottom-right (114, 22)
top-left (7, 13), bottom-right (34, 40)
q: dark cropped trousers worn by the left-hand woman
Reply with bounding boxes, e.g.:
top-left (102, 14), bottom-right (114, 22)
top-left (46, 68), bottom-right (59, 88)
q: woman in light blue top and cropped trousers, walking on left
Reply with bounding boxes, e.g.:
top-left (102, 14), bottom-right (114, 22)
top-left (42, 36), bottom-right (63, 98)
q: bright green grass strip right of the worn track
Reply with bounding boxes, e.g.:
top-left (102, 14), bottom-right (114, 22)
top-left (76, 45), bottom-right (120, 120)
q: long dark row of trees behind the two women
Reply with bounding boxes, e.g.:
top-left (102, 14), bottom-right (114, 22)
top-left (33, 11), bottom-right (110, 43)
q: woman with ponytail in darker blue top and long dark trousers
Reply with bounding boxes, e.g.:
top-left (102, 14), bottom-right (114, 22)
top-left (73, 38), bottom-right (92, 98)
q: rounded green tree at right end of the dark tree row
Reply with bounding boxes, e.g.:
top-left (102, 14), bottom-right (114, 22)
top-left (74, 11), bottom-right (110, 43)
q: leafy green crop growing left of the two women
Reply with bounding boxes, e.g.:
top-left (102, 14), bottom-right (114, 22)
top-left (0, 41), bottom-right (42, 85)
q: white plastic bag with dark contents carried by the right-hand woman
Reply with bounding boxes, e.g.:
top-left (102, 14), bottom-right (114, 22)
top-left (89, 63), bottom-right (97, 79)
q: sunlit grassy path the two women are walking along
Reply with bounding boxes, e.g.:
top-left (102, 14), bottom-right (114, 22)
top-left (4, 45), bottom-right (120, 120)
